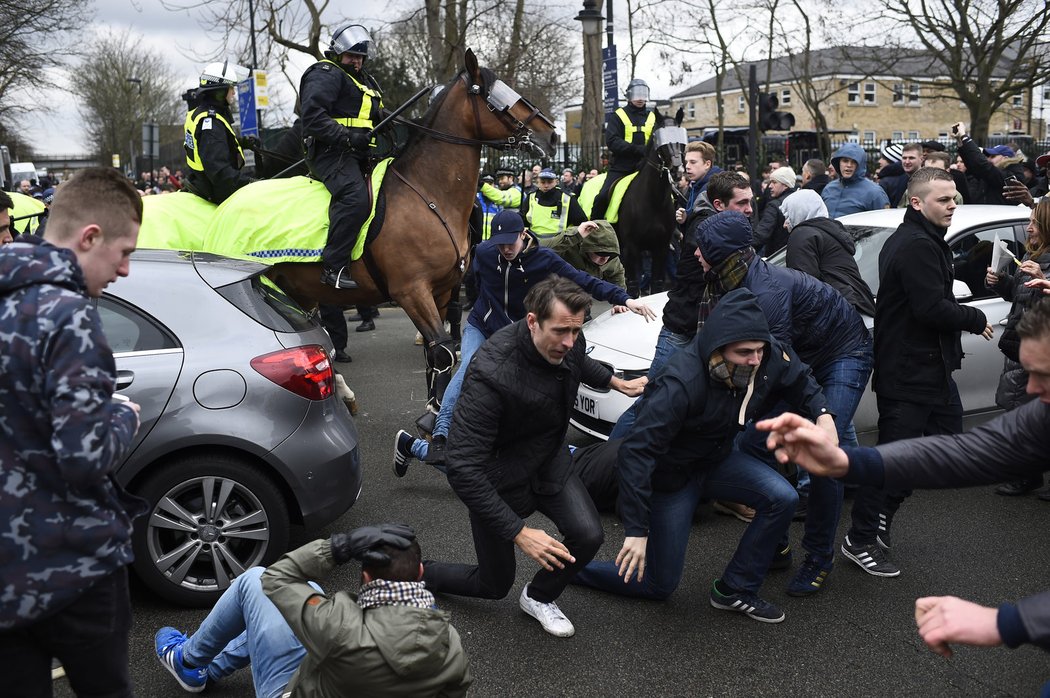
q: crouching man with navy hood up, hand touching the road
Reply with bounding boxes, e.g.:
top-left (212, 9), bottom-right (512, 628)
top-left (575, 285), bottom-right (835, 622)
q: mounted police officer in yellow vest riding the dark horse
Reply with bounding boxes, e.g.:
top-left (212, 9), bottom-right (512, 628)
top-left (591, 79), bottom-right (656, 218)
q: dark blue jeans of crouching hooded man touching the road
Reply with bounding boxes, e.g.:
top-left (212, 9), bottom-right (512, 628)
top-left (575, 450), bottom-right (798, 599)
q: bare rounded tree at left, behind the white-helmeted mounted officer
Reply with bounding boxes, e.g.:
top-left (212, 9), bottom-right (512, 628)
top-left (72, 31), bottom-right (186, 167)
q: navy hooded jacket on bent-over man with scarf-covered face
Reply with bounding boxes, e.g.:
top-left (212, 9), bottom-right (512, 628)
top-left (696, 209), bottom-right (869, 366)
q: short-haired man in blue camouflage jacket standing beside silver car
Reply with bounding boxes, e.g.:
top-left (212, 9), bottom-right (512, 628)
top-left (0, 167), bottom-right (146, 696)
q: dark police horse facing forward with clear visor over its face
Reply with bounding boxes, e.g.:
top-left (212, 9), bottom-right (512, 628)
top-left (613, 108), bottom-right (688, 297)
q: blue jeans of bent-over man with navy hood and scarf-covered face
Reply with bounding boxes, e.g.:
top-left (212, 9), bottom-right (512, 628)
top-left (741, 337), bottom-right (874, 562)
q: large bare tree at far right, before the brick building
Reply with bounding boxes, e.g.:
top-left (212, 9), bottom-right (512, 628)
top-left (881, 0), bottom-right (1050, 141)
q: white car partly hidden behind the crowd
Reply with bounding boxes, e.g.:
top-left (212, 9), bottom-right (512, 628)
top-left (571, 206), bottom-right (1030, 443)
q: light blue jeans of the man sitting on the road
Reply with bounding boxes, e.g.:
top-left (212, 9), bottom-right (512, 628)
top-left (183, 567), bottom-right (320, 698)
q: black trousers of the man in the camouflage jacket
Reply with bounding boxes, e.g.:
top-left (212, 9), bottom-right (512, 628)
top-left (0, 568), bottom-right (133, 698)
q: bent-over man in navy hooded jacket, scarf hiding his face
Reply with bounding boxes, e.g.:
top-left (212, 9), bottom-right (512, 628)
top-left (696, 211), bottom-right (873, 596)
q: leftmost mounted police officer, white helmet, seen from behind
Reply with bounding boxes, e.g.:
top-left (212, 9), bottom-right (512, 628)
top-left (183, 61), bottom-right (252, 204)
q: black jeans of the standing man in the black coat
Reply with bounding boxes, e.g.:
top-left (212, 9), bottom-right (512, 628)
top-left (849, 378), bottom-right (963, 545)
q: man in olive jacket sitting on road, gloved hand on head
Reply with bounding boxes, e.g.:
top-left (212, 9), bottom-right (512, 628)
top-left (154, 524), bottom-right (471, 698)
